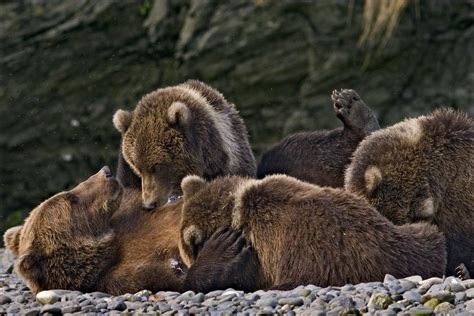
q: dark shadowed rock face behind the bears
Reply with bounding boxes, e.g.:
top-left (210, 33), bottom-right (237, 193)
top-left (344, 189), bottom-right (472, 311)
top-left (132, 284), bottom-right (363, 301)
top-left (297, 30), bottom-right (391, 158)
top-left (0, 0), bottom-right (474, 242)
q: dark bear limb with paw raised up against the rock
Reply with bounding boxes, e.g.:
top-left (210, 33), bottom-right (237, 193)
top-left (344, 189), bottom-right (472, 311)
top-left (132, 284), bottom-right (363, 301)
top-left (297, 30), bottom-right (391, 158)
top-left (257, 89), bottom-right (380, 187)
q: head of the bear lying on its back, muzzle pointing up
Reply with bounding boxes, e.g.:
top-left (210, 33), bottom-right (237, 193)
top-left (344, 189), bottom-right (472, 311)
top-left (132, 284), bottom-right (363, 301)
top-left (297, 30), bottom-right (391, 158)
top-left (10, 167), bottom-right (122, 292)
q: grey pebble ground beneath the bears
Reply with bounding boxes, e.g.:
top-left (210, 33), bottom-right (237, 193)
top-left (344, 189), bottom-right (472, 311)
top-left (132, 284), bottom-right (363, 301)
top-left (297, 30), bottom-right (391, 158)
top-left (0, 249), bottom-right (474, 315)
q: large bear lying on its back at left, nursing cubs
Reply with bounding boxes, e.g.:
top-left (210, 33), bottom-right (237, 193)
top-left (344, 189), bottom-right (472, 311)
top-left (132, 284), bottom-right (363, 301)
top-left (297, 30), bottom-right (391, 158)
top-left (4, 168), bottom-right (254, 295)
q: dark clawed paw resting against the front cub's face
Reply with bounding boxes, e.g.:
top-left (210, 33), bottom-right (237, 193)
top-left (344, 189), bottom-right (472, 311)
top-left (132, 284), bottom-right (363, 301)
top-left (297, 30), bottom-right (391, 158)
top-left (184, 228), bottom-right (259, 293)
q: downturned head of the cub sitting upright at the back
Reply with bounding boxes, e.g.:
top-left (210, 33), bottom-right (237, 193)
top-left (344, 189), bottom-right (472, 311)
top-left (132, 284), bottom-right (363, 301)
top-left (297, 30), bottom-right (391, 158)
top-left (113, 86), bottom-right (212, 209)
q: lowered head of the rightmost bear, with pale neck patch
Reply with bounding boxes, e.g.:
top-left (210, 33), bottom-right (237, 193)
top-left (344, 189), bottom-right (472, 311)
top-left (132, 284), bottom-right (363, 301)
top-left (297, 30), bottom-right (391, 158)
top-left (345, 115), bottom-right (439, 224)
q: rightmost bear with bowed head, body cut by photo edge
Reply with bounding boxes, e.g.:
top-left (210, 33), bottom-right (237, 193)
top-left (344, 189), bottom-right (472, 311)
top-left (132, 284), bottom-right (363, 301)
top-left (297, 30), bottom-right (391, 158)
top-left (345, 110), bottom-right (474, 274)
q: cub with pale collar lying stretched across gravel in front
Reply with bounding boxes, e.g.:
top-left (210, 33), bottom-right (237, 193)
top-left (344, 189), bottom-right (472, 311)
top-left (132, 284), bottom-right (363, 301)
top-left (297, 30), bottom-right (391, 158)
top-left (179, 175), bottom-right (446, 289)
